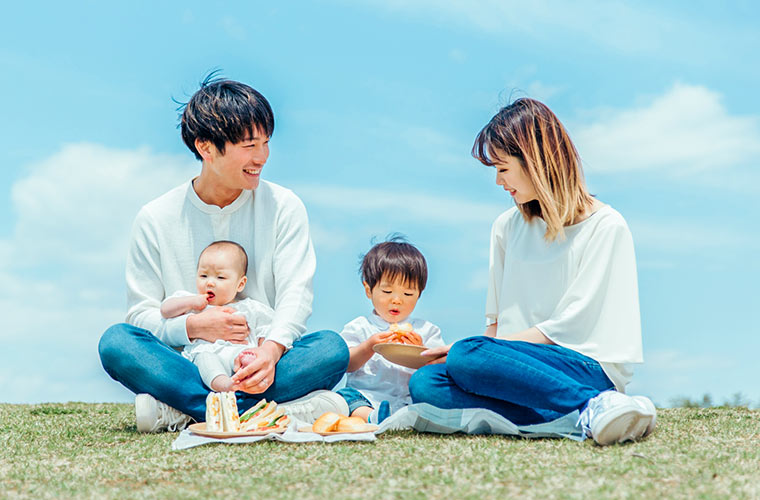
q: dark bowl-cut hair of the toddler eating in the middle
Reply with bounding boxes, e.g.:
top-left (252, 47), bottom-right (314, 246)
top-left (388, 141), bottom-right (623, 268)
top-left (361, 235), bottom-right (427, 293)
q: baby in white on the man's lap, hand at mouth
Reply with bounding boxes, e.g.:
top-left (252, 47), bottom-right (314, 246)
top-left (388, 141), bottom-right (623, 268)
top-left (161, 241), bottom-right (274, 392)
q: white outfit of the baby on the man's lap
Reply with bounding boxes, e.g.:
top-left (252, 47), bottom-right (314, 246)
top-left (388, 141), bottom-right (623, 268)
top-left (169, 291), bottom-right (274, 388)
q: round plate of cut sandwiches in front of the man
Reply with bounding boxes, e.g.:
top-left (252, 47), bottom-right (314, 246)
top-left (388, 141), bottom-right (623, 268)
top-left (188, 392), bottom-right (290, 438)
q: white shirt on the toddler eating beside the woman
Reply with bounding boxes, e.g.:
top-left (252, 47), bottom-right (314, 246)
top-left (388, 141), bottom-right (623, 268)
top-left (340, 313), bottom-right (444, 412)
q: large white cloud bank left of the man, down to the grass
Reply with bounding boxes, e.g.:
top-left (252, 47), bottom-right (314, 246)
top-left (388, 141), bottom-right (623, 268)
top-left (0, 144), bottom-right (198, 402)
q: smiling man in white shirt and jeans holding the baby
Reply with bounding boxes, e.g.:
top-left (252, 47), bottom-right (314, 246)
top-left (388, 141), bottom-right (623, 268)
top-left (99, 73), bottom-right (349, 432)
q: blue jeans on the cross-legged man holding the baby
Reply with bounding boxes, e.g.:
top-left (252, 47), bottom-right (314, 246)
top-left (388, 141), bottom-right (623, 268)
top-left (98, 323), bottom-right (348, 421)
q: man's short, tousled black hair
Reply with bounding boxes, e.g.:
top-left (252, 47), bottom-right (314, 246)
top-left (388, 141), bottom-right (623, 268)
top-left (178, 71), bottom-right (274, 160)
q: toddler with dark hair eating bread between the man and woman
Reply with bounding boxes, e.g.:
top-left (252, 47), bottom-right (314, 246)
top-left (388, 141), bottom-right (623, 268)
top-left (337, 237), bottom-right (444, 424)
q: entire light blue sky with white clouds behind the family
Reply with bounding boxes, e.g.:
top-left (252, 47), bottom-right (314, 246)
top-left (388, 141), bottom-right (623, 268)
top-left (0, 0), bottom-right (760, 405)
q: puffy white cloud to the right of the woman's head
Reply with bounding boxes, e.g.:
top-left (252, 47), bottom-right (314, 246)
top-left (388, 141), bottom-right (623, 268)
top-left (574, 84), bottom-right (760, 174)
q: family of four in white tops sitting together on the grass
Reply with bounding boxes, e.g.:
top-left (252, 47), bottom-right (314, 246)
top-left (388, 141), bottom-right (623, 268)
top-left (99, 77), bottom-right (656, 445)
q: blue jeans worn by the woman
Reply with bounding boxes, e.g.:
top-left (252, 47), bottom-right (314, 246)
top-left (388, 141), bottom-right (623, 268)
top-left (409, 336), bottom-right (614, 425)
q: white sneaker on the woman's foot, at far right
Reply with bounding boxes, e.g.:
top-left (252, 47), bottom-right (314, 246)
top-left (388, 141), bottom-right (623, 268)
top-left (579, 390), bottom-right (656, 446)
